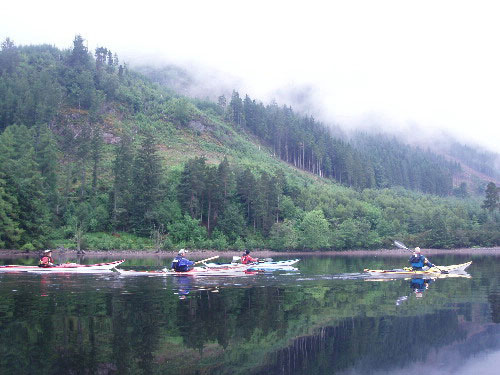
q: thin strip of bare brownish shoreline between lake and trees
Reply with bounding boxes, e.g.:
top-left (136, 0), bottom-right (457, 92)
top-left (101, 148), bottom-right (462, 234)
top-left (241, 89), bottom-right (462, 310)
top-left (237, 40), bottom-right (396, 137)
top-left (0, 247), bottom-right (500, 260)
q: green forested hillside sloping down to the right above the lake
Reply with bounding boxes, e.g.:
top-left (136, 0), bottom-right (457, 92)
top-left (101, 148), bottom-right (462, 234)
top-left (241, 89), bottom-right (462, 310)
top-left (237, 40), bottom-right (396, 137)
top-left (0, 36), bottom-right (500, 250)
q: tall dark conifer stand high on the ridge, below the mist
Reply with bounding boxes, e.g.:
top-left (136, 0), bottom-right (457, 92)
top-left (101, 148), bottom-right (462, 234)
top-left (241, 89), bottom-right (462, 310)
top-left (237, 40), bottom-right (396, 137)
top-left (219, 91), bottom-right (460, 196)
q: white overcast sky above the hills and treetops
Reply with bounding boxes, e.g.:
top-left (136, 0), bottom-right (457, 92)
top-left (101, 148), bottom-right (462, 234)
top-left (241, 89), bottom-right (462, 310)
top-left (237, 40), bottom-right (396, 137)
top-left (0, 0), bottom-right (500, 152)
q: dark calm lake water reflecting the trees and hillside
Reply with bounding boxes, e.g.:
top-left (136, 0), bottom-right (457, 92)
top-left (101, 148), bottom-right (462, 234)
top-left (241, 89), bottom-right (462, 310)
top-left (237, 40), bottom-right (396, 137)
top-left (0, 254), bottom-right (500, 375)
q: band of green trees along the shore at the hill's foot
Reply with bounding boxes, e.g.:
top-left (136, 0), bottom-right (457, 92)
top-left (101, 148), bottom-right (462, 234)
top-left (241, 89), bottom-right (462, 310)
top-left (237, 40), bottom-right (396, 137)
top-left (0, 125), bottom-right (500, 250)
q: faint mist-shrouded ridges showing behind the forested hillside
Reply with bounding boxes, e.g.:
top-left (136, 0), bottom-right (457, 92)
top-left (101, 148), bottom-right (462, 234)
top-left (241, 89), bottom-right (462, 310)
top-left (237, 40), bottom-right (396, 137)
top-left (133, 61), bottom-right (500, 189)
